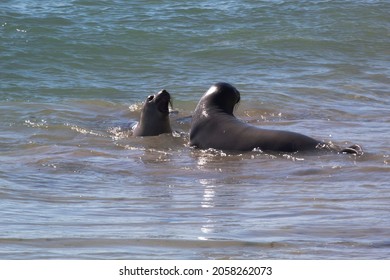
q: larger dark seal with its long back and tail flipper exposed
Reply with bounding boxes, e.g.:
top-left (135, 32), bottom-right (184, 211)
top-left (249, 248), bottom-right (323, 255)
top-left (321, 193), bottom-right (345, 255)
top-left (190, 83), bottom-right (361, 153)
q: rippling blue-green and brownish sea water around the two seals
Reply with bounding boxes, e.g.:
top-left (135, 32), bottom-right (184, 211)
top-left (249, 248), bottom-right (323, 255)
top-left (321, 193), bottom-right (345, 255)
top-left (0, 0), bottom-right (390, 259)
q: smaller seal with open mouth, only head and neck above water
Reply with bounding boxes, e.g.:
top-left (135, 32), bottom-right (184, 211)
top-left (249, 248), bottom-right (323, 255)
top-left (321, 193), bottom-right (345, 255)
top-left (133, 89), bottom-right (172, 136)
